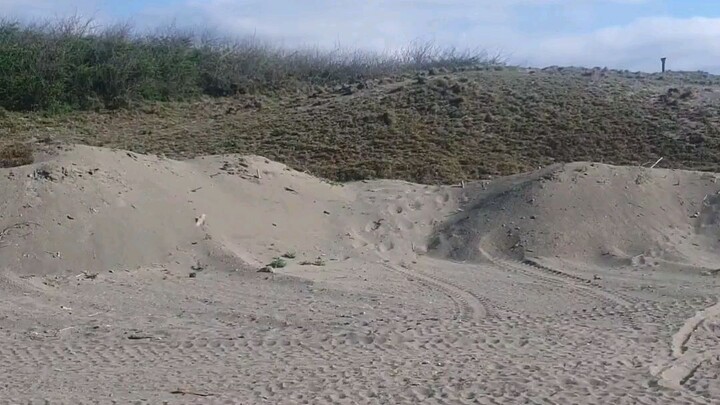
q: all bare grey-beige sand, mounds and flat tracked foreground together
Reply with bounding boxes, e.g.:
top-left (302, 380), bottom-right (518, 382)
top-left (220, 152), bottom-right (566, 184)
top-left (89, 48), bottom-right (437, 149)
top-left (0, 146), bottom-right (720, 404)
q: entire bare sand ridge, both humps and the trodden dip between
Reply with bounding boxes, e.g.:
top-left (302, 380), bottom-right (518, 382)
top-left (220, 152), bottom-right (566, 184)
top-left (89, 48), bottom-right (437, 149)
top-left (0, 146), bottom-right (720, 274)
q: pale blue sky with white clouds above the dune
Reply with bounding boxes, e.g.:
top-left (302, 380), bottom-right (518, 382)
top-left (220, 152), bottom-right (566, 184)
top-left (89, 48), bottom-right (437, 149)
top-left (0, 0), bottom-right (720, 73)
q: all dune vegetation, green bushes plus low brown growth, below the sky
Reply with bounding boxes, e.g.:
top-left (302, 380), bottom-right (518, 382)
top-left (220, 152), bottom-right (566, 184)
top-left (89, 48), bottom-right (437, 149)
top-left (0, 18), bottom-right (720, 183)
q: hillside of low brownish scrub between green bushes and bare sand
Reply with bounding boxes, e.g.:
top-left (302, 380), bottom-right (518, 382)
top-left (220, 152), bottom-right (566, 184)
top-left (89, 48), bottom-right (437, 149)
top-left (0, 66), bottom-right (720, 183)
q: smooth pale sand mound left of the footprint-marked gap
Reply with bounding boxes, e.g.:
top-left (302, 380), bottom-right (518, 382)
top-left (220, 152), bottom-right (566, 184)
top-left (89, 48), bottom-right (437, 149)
top-left (0, 146), bottom-right (354, 274)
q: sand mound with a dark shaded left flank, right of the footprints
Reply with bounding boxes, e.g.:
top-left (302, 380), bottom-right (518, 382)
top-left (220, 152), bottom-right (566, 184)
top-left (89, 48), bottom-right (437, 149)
top-left (430, 163), bottom-right (720, 268)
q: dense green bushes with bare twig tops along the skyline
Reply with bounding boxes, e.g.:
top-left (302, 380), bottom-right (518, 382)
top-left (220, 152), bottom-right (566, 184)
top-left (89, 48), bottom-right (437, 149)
top-left (0, 18), bottom-right (499, 110)
